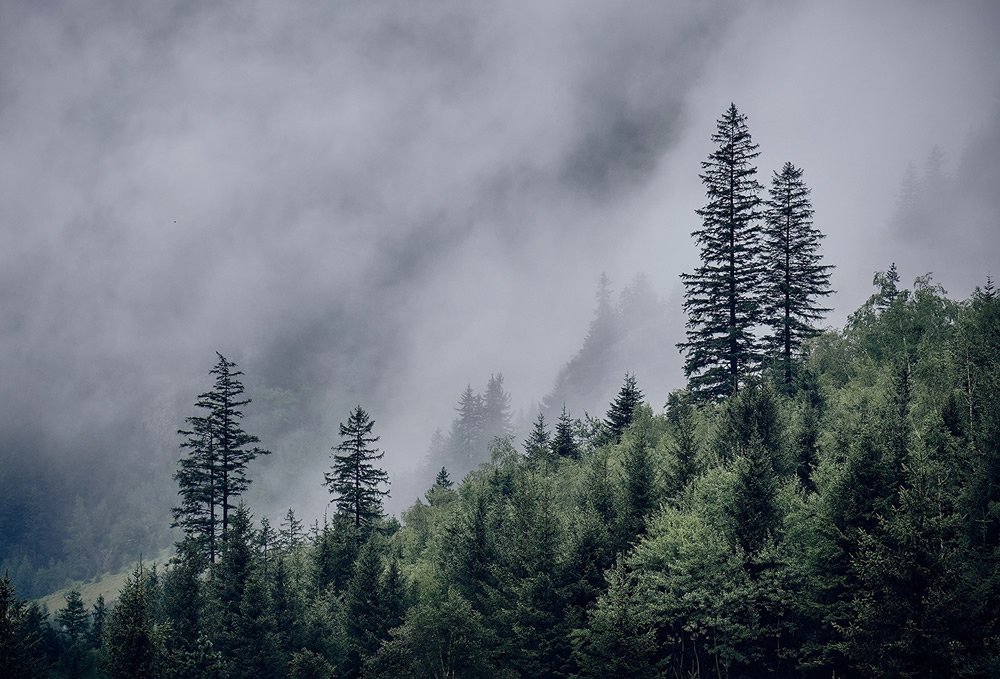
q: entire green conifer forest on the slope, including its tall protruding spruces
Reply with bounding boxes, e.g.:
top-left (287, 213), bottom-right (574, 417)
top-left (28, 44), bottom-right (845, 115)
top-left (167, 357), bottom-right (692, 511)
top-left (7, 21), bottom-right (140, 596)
top-left (0, 105), bottom-right (1000, 679)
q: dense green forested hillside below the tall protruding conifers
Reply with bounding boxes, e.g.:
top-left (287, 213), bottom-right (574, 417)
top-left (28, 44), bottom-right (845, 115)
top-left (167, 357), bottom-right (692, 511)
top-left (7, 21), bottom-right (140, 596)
top-left (0, 269), bottom-right (1000, 677)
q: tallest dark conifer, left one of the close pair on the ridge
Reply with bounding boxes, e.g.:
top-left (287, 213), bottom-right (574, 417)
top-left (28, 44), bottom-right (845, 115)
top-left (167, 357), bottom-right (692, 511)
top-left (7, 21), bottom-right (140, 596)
top-left (678, 104), bottom-right (763, 399)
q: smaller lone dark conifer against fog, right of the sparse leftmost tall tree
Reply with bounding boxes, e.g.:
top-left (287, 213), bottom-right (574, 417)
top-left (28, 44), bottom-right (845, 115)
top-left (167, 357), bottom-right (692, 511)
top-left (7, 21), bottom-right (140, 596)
top-left (324, 405), bottom-right (389, 530)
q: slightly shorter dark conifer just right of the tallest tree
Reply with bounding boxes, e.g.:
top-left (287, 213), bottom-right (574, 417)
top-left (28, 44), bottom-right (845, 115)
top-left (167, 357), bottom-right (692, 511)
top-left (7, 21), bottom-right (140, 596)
top-left (763, 163), bottom-right (833, 384)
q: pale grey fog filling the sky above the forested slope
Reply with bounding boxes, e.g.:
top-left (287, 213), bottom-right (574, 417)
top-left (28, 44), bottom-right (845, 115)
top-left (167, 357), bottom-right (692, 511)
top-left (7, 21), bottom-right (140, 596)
top-left (0, 0), bottom-right (1000, 518)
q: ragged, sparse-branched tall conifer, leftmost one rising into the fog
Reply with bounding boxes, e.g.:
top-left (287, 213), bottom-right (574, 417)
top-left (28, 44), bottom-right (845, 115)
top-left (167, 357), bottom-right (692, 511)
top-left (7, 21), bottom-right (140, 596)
top-left (171, 352), bottom-right (270, 563)
